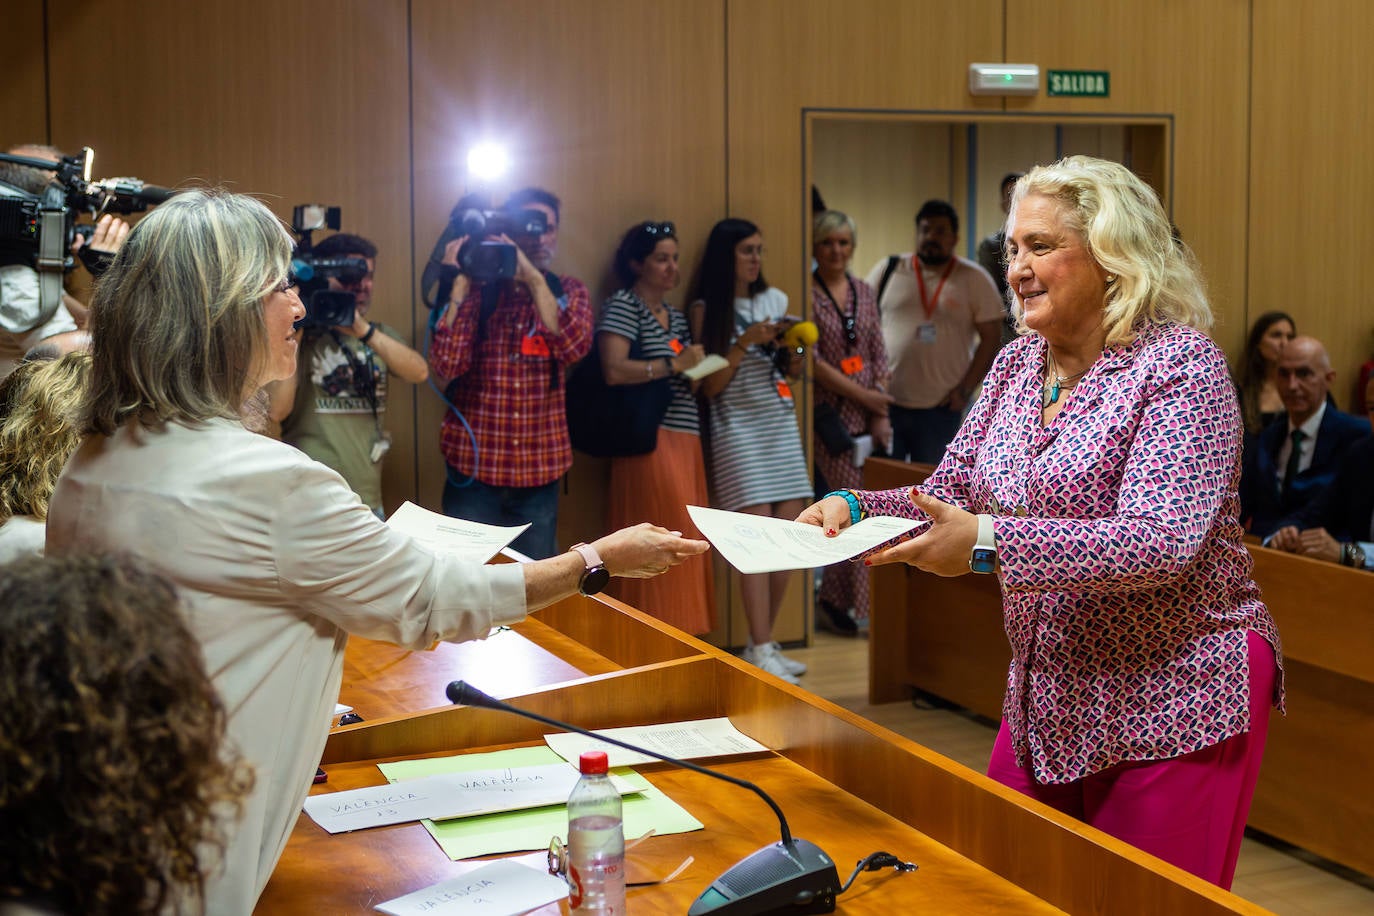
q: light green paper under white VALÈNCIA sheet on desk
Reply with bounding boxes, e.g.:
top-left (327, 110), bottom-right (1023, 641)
top-left (378, 747), bottom-right (701, 860)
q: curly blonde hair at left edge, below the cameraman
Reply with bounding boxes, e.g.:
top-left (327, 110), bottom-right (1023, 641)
top-left (0, 350), bottom-right (91, 522)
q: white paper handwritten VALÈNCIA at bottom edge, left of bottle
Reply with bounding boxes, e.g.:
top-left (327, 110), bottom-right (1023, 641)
top-left (375, 860), bottom-right (567, 916)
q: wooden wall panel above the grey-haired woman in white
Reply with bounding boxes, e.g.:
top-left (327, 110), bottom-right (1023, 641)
top-left (42, 0), bottom-right (415, 507)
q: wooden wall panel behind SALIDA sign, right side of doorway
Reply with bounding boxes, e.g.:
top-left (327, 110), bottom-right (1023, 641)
top-left (1006, 0), bottom-right (1253, 357)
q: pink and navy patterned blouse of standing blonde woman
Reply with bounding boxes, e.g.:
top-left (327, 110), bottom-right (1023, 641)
top-left (861, 327), bottom-right (1283, 783)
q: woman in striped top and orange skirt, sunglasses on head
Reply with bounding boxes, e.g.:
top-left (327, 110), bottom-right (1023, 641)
top-left (596, 222), bottom-right (716, 634)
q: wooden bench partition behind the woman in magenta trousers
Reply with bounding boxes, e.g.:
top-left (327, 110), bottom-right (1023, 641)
top-left (864, 459), bottom-right (1374, 875)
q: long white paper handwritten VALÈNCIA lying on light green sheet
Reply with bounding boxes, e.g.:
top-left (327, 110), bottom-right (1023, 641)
top-left (305, 761), bottom-right (639, 834)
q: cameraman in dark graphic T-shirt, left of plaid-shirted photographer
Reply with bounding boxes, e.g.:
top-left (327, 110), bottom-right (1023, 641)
top-left (268, 232), bottom-right (429, 516)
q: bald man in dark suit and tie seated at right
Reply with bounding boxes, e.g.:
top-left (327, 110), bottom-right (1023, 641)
top-left (1241, 336), bottom-right (1370, 537)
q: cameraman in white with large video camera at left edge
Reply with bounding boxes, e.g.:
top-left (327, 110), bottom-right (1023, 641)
top-left (0, 143), bottom-right (142, 378)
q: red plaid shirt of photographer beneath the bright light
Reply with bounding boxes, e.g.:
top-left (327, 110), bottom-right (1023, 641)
top-left (430, 276), bottom-right (592, 486)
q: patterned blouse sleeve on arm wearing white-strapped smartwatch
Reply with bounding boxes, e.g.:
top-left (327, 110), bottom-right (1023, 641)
top-left (996, 335), bottom-right (1241, 592)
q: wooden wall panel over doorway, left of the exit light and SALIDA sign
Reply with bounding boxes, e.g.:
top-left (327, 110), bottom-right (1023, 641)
top-left (725, 0), bottom-right (1002, 641)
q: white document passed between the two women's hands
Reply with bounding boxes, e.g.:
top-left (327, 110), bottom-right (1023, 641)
top-left (687, 505), bottom-right (921, 573)
